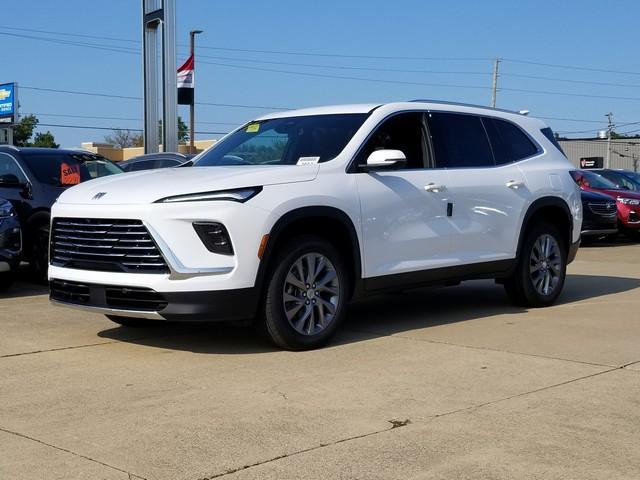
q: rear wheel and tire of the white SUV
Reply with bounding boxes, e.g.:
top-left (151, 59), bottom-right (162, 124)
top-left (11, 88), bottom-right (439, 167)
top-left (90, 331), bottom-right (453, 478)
top-left (504, 223), bottom-right (567, 307)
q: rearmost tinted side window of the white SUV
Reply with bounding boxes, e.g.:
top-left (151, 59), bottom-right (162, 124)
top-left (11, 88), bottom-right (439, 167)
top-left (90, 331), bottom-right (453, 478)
top-left (482, 117), bottom-right (538, 165)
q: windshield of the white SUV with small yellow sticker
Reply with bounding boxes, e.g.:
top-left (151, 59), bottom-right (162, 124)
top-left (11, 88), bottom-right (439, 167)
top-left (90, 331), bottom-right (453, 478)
top-left (194, 113), bottom-right (368, 167)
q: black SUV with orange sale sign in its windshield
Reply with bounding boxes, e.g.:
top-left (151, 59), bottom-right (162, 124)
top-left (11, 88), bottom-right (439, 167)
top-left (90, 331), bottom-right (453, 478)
top-left (0, 145), bottom-right (122, 279)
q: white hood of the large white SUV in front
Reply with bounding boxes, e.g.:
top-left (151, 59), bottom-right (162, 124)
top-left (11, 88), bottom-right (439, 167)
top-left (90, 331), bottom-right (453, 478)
top-left (58, 165), bottom-right (319, 205)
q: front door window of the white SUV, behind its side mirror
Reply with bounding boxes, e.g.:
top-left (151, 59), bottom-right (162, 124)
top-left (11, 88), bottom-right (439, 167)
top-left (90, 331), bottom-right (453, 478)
top-left (357, 113), bottom-right (425, 169)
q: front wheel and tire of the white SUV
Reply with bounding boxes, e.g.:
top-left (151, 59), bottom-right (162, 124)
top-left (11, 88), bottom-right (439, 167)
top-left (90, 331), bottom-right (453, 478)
top-left (262, 235), bottom-right (349, 350)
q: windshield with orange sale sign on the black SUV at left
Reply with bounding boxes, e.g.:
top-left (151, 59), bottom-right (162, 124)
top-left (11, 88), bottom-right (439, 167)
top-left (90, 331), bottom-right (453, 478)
top-left (22, 153), bottom-right (122, 187)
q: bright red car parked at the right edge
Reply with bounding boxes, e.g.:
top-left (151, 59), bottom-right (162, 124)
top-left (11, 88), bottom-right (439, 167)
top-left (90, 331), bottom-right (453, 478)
top-left (571, 170), bottom-right (640, 239)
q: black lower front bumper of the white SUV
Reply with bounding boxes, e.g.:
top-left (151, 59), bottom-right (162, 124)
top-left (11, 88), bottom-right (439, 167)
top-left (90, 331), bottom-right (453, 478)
top-left (50, 279), bottom-right (259, 322)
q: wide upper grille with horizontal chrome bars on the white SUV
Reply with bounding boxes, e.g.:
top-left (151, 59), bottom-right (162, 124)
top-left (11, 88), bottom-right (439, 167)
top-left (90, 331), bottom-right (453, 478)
top-left (50, 218), bottom-right (169, 273)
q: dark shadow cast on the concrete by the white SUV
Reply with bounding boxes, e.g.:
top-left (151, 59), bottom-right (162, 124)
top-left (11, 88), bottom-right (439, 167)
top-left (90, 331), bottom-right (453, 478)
top-left (98, 275), bottom-right (640, 355)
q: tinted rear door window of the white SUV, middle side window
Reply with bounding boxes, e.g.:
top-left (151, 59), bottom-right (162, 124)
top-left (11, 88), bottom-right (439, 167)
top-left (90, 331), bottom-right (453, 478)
top-left (428, 112), bottom-right (494, 168)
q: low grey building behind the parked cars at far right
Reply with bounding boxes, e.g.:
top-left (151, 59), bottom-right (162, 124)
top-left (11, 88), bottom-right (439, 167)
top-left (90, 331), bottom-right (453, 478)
top-left (558, 138), bottom-right (640, 172)
